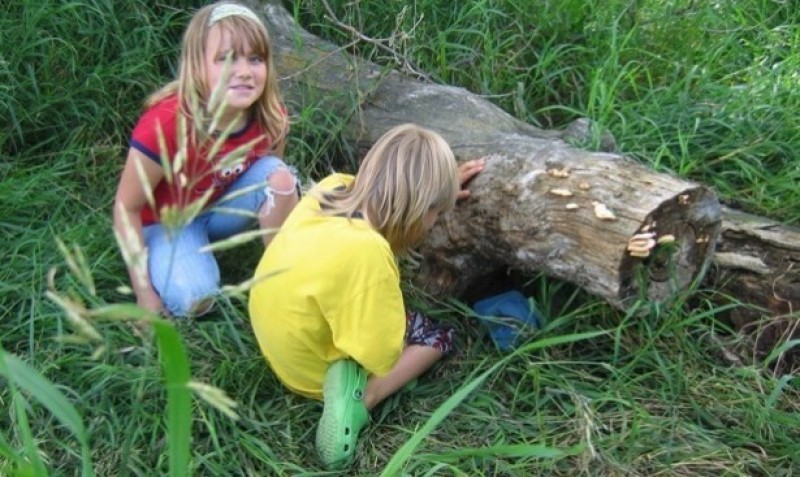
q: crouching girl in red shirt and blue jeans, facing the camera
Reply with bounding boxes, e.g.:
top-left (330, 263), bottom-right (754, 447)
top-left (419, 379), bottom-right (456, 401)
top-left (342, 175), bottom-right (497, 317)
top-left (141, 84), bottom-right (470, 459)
top-left (114, 2), bottom-right (298, 317)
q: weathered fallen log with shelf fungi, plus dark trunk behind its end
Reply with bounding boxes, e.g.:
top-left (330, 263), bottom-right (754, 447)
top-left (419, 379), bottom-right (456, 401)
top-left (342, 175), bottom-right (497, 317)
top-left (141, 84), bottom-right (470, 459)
top-left (263, 0), bottom-right (800, 319)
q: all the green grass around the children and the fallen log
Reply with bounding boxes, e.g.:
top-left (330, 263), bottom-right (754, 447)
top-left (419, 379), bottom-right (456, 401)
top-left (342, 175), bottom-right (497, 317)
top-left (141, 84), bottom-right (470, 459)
top-left (0, 0), bottom-right (800, 476)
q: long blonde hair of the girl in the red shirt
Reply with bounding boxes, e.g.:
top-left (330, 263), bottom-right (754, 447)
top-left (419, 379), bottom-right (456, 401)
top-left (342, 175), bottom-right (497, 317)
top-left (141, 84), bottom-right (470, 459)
top-left (145, 2), bottom-right (289, 143)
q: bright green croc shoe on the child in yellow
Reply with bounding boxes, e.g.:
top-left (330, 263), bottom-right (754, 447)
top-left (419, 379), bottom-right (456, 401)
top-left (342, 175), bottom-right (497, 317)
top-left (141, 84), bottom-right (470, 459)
top-left (317, 359), bottom-right (369, 470)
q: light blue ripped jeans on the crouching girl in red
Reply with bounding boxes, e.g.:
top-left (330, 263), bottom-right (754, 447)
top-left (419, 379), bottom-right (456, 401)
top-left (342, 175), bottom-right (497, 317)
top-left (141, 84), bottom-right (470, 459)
top-left (143, 156), bottom-right (296, 317)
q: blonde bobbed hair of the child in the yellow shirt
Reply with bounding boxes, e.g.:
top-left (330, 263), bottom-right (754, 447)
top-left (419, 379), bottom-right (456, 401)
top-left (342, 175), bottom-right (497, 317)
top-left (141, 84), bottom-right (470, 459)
top-left (319, 124), bottom-right (460, 254)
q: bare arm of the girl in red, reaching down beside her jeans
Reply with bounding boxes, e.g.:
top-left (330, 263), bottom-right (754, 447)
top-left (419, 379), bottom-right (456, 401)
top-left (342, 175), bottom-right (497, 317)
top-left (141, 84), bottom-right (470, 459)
top-left (114, 148), bottom-right (164, 312)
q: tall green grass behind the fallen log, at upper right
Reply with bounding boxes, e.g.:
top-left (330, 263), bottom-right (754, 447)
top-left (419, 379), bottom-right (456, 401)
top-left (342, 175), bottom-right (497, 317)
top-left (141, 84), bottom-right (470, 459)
top-left (301, 0), bottom-right (800, 224)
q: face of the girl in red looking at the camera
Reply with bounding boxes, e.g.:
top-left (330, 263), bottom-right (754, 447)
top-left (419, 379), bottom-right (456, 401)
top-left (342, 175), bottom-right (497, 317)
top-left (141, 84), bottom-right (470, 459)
top-left (205, 25), bottom-right (267, 125)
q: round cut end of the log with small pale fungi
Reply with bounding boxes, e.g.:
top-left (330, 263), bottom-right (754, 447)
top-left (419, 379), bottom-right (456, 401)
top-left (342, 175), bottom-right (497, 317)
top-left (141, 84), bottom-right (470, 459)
top-left (619, 187), bottom-right (721, 306)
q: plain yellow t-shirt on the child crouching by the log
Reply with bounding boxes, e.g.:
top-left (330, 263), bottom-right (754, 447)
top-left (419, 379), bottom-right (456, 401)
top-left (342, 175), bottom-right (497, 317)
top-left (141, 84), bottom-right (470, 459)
top-left (249, 174), bottom-right (406, 399)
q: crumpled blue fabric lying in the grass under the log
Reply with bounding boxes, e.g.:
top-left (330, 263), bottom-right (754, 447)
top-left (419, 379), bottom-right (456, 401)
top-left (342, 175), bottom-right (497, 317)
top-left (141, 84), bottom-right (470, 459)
top-left (473, 290), bottom-right (542, 351)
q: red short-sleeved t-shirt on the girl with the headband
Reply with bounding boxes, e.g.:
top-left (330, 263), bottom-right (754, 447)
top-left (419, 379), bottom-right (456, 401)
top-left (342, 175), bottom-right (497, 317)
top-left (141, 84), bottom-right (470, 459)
top-left (130, 96), bottom-right (271, 225)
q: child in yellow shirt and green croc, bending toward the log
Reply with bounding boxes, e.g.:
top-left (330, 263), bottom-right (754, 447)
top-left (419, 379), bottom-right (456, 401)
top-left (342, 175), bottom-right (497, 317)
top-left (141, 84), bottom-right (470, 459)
top-left (249, 124), bottom-right (483, 469)
